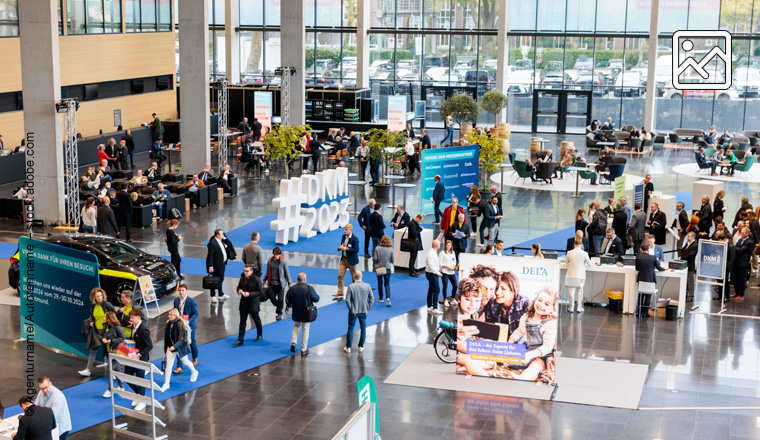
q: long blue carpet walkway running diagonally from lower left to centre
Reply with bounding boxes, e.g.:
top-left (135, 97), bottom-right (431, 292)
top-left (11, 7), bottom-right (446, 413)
top-left (0, 258), bottom-right (434, 432)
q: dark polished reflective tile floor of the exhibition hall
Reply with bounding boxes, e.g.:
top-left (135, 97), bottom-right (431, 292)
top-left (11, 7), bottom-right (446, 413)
top-left (0, 133), bottom-right (760, 440)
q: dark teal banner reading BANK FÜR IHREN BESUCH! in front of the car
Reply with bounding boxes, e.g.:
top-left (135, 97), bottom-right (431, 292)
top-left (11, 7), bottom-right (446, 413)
top-left (18, 237), bottom-right (100, 357)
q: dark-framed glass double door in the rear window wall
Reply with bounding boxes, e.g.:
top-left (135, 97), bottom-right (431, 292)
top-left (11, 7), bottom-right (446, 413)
top-left (532, 89), bottom-right (591, 134)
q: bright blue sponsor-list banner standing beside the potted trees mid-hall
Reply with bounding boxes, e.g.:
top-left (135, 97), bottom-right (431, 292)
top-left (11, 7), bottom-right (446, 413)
top-left (421, 145), bottom-right (480, 213)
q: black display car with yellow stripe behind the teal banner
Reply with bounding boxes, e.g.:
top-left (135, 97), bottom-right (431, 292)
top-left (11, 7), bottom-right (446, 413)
top-left (8, 234), bottom-right (179, 304)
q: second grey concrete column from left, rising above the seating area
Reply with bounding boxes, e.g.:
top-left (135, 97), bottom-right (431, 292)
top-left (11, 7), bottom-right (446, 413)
top-left (177, 0), bottom-right (211, 174)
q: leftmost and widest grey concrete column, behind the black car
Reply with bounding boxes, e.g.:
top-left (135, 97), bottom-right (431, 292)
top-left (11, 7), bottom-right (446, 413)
top-left (18, 0), bottom-right (66, 224)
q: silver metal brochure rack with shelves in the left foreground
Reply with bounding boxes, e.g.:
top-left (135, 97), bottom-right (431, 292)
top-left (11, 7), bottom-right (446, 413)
top-left (108, 353), bottom-right (169, 440)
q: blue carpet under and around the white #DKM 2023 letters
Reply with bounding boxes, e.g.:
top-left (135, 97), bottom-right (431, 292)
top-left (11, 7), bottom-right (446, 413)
top-left (201, 214), bottom-right (430, 257)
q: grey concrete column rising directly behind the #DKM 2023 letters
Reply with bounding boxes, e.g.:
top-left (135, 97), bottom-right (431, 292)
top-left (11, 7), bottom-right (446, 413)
top-left (280, 0), bottom-right (306, 124)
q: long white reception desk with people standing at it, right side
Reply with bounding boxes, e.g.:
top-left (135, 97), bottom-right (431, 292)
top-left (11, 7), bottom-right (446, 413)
top-left (561, 258), bottom-right (686, 318)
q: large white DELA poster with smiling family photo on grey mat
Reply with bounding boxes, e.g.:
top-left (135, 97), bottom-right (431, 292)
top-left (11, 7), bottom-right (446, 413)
top-left (456, 254), bottom-right (560, 383)
